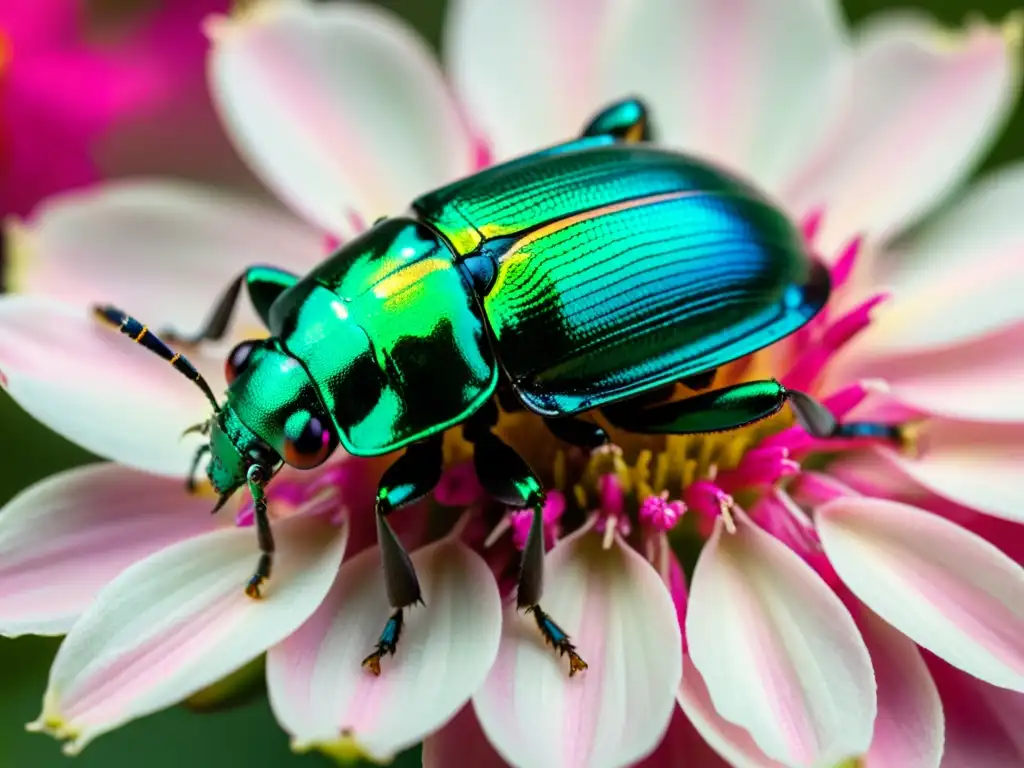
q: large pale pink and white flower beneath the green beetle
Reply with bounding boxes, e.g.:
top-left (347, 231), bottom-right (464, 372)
top-left (0, 0), bottom-right (1024, 768)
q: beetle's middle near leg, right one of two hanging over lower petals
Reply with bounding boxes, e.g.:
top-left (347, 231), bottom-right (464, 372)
top-left (465, 425), bottom-right (587, 677)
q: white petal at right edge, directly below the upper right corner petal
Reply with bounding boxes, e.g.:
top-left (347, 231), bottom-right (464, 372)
top-left (862, 164), bottom-right (1024, 355)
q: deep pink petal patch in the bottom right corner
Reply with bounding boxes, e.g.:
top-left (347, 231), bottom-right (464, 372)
top-left (926, 654), bottom-right (1024, 768)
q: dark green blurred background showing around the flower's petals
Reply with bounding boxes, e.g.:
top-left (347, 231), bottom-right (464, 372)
top-left (0, 0), bottom-right (1024, 768)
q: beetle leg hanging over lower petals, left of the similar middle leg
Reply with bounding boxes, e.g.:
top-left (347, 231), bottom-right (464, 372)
top-left (362, 435), bottom-right (443, 675)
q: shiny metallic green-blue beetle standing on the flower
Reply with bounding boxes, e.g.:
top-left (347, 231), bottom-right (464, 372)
top-left (96, 100), bottom-right (891, 674)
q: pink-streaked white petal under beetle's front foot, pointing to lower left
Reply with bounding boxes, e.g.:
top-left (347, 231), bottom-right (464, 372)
top-left (31, 518), bottom-right (347, 753)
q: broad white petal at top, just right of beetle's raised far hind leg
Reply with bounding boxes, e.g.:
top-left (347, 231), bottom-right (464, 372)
top-left (598, 0), bottom-right (848, 191)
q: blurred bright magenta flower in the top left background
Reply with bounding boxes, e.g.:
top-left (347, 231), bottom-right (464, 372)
top-left (0, 0), bottom-right (243, 215)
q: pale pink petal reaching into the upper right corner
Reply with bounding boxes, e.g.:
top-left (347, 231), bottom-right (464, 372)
top-left (786, 16), bottom-right (1019, 252)
